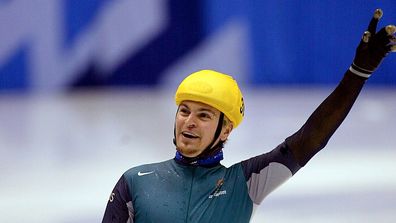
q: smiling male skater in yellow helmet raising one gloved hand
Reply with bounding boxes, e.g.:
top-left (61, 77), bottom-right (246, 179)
top-left (103, 9), bottom-right (396, 223)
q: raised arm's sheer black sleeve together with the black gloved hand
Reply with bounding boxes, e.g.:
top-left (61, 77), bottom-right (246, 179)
top-left (286, 9), bottom-right (396, 166)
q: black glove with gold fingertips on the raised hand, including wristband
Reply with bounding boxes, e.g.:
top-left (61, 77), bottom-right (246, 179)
top-left (349, 9), bottom-right (396, 78)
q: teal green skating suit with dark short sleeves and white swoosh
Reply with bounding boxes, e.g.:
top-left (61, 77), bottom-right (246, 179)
top-left (103, 143), bottom-right (300, 223)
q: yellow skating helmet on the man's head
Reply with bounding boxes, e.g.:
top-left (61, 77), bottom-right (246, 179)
top-left (175, 70), bottom-right (245, 128)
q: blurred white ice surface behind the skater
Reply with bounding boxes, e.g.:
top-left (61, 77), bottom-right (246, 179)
top-left (0, 88), bottom-right (396, 223)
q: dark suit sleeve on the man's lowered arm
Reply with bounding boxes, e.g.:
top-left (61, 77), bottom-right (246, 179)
top-left (102, 175), bottom-right (134, 223)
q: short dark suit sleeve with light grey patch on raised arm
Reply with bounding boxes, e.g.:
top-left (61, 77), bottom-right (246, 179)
top-left (241, 143), bottom-right (300, 205)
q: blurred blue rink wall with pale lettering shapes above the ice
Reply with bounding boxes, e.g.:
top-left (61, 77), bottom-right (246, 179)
top-left (0, 0), bottom-right (396, 92)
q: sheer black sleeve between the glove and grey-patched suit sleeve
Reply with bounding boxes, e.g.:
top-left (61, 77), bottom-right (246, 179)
top-left (286, 71), bottom-right (367, 166)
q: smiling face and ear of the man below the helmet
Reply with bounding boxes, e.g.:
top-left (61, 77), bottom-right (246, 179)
top-left (175, 101), bottom-right (232, 157)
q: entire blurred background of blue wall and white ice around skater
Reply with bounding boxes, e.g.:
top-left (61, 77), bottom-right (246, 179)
top-left (0, 0), bottom-right (396, 223)
